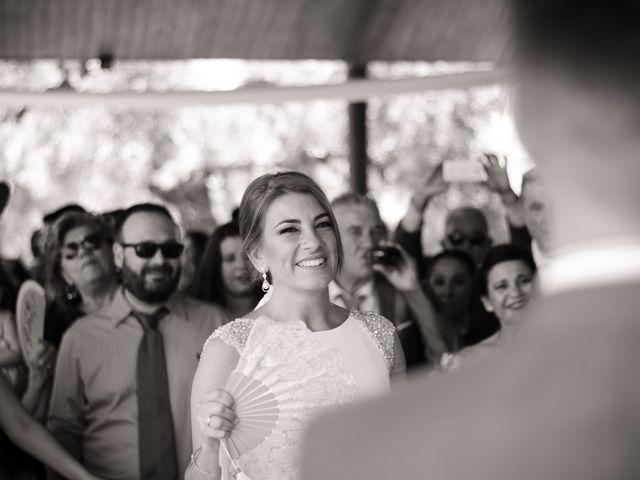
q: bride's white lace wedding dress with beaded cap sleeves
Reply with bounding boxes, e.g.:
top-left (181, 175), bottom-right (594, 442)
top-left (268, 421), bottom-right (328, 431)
top-left (210, 310), bottom-right (394, 480)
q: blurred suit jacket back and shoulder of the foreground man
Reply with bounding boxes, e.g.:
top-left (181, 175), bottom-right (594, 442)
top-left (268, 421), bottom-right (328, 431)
top-left (303, 281), bottom-right (640, 480)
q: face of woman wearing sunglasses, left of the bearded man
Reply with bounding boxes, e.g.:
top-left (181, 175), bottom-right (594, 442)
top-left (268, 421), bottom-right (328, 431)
top-left (60, 226), bottom-right (115, 288)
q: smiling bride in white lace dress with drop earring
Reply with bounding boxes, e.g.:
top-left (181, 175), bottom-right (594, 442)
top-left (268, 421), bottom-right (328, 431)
top-left (185, 172), bottom-right (404, 480)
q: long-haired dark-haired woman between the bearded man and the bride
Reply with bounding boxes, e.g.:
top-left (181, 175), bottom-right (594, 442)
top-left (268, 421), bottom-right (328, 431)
top-left (191, 222), bottom-right (261, 318)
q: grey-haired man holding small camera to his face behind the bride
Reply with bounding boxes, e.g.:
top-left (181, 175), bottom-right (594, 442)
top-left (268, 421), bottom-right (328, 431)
top-left (329, 193), bottom-right (444, 368)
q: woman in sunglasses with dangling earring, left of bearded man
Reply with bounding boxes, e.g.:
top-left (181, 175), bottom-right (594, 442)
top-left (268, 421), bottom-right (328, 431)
top-left (45, 212), bottom-right (118, 347)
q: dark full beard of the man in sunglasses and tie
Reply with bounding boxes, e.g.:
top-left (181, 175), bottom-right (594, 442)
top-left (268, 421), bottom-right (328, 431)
top-left (122, 262), bottom-right (180, 303)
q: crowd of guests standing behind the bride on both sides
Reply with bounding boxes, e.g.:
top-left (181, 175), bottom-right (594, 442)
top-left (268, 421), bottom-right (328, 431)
top-left (0, 148), bottom-right (549, 478)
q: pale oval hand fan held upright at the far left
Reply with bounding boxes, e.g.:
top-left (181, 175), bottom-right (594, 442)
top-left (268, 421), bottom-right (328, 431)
top-left (16, 280), bottom-right (47, 357)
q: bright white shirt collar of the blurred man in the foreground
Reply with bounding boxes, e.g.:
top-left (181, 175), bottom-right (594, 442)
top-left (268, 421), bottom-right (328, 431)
top-left (539, 238), bottom-right (640, 295)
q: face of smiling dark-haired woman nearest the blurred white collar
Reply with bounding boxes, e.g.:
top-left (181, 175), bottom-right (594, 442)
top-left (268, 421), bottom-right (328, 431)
top-left (482, 260), bottom-right (533, 325)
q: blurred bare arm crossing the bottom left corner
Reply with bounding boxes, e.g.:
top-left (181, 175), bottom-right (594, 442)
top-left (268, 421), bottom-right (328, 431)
top-left (0, 375), bottom-right (104, 480)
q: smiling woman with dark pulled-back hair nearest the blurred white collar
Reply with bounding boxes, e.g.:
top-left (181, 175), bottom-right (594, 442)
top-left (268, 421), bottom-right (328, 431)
top-left (448, 244), bottom-right (536, 367)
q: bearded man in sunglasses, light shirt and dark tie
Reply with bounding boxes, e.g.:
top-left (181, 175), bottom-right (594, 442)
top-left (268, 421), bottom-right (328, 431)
top-left (49, 204), bottom-right (230, 480)
